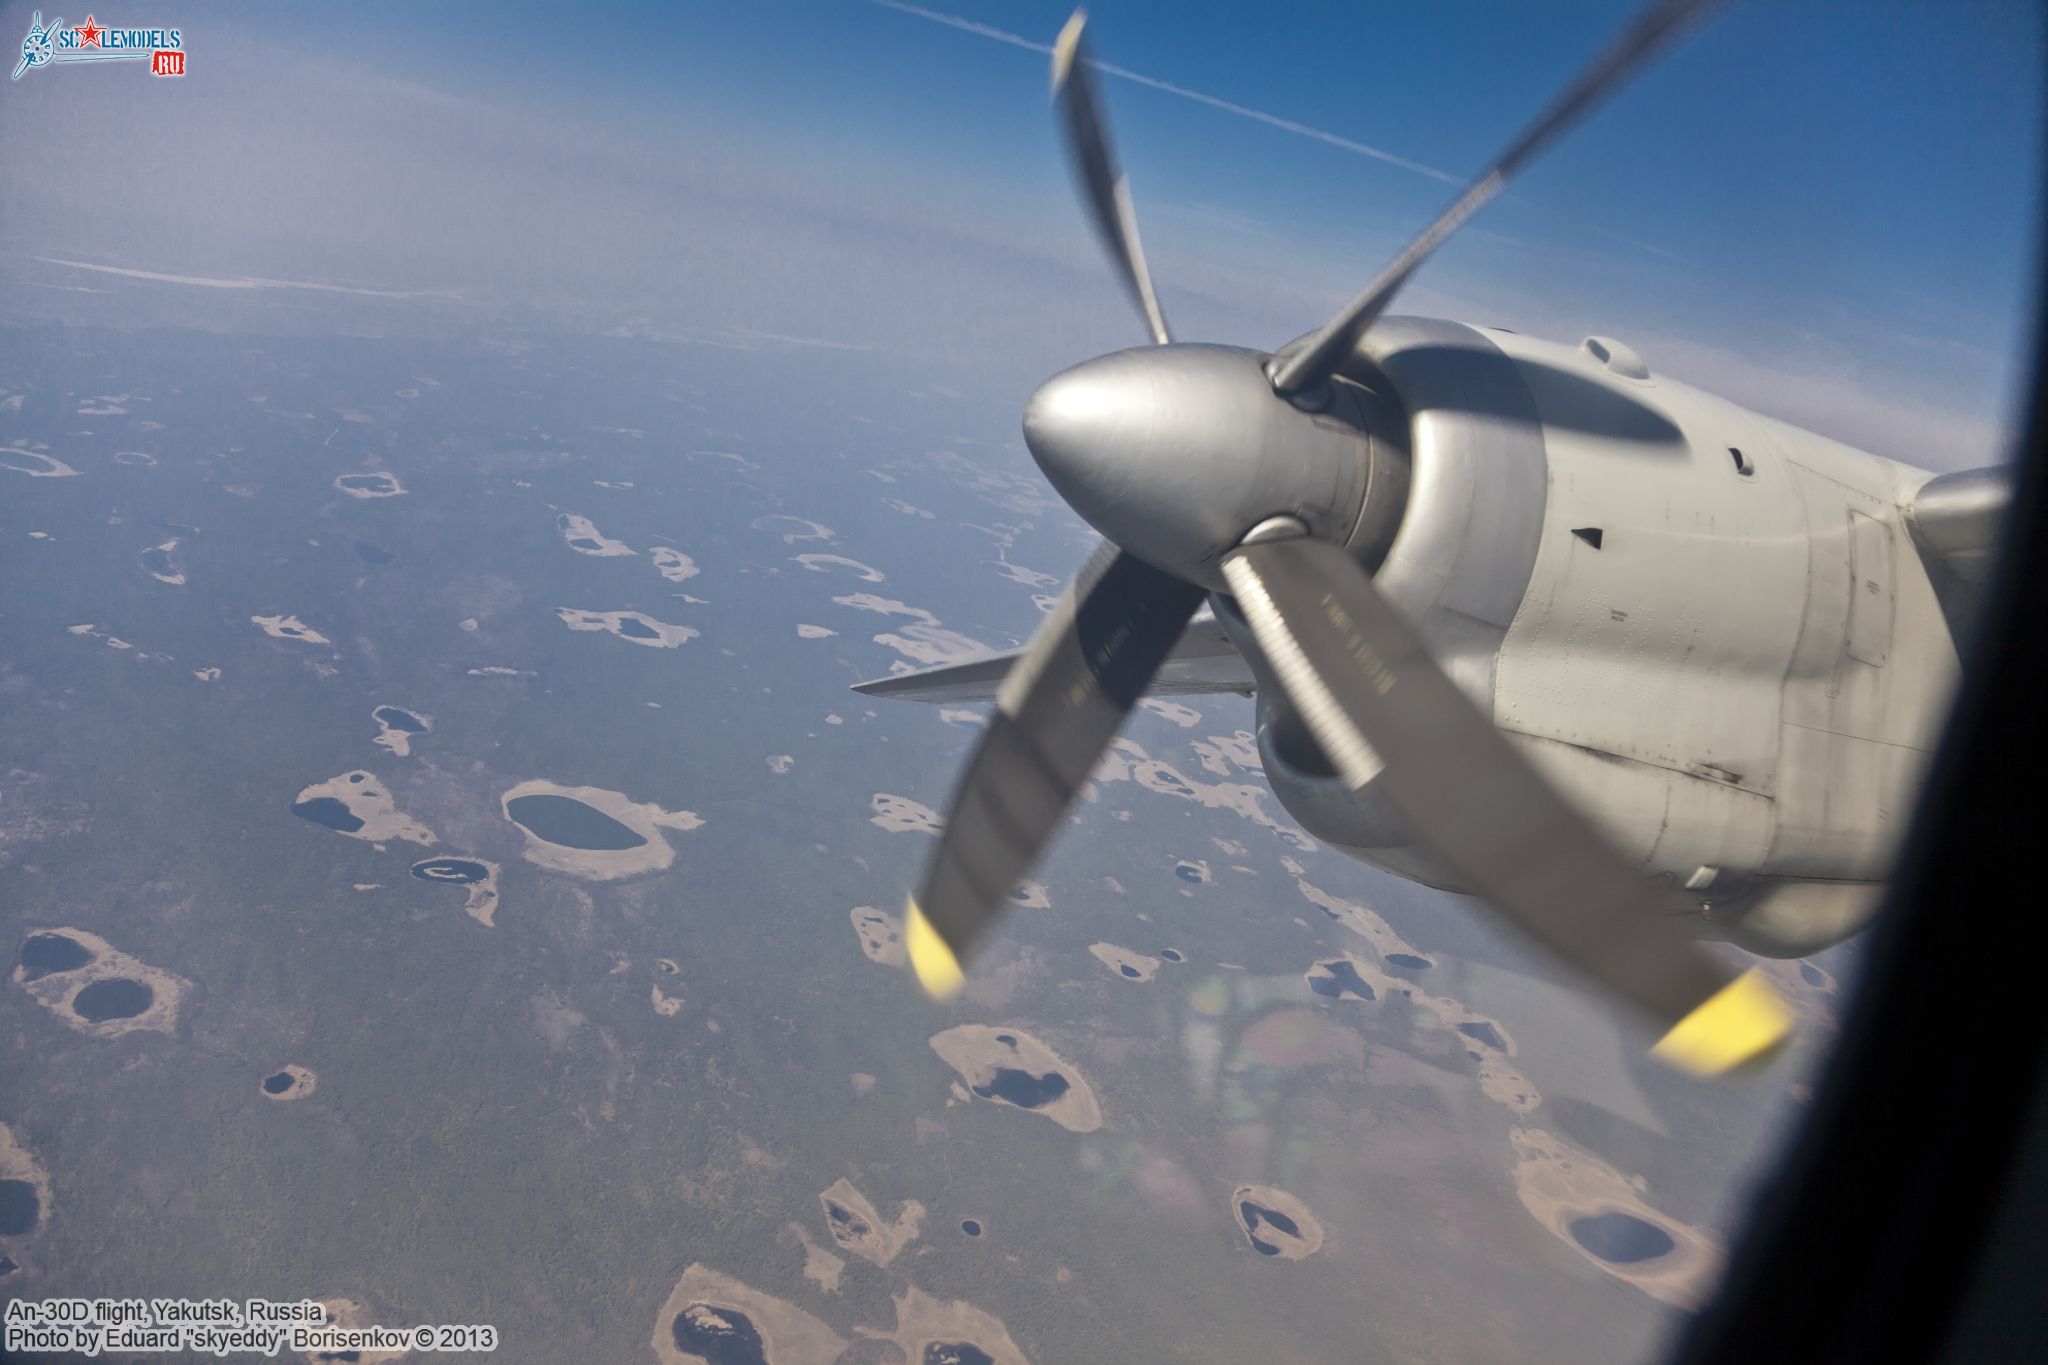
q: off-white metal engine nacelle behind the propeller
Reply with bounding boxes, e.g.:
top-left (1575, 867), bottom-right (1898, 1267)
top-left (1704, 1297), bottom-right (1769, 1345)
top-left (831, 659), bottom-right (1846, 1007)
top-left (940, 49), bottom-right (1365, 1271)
top-left (1214, 317), bottom-right (1900, 956)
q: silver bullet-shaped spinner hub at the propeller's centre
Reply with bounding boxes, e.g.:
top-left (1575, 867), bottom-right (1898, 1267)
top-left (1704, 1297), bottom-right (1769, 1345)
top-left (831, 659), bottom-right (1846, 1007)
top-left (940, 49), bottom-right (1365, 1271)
top-left (1024, 344), bottom-right (1407, 591)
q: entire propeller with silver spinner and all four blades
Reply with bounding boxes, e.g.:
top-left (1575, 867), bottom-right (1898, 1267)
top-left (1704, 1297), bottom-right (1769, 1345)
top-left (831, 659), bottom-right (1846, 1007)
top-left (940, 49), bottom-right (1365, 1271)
top-left (888, 0), bottom-right (1790, 1074)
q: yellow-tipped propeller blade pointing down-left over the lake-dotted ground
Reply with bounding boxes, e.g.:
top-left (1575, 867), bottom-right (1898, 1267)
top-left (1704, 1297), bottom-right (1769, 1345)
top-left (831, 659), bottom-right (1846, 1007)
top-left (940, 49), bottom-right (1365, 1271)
top-left (903, 544), bottom-right (1206, 999)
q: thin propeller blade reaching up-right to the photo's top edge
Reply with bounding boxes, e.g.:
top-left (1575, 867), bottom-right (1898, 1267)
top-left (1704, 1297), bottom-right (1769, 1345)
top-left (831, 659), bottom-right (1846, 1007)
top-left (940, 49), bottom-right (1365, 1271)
top-left (1268, 0), bottom-right (1720, 395)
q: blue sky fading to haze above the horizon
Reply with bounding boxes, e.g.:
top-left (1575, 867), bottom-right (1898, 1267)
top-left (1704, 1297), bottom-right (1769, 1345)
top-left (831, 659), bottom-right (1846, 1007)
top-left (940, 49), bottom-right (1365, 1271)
top-left (0, 0), bottom-right (2044, 469)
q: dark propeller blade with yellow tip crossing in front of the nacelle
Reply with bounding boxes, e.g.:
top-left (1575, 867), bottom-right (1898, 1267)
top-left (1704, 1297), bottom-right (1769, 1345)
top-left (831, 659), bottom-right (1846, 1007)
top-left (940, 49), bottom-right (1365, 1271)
top-left (1223, 538), bottom-right (1792, 1074)
